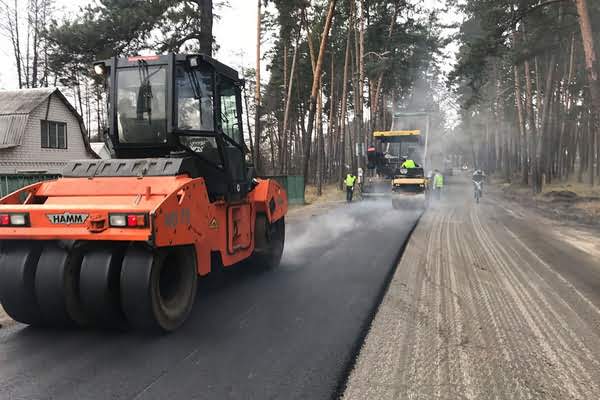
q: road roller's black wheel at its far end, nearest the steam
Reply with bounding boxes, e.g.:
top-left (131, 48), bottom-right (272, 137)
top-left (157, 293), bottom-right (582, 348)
top-left (248, 214), bottom-right (285, 270)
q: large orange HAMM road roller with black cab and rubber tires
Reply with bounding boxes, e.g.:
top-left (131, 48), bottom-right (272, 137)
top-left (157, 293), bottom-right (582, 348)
top-left (0, 54), bottom-right (287, 332)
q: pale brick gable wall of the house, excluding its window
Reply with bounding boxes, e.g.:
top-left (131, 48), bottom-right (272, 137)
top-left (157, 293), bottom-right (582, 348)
top-left (0, 95), bottom-right (92, 174)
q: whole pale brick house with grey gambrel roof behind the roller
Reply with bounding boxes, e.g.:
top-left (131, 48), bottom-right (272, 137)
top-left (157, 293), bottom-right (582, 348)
top-left (0, 88), bottom-right (98, 175)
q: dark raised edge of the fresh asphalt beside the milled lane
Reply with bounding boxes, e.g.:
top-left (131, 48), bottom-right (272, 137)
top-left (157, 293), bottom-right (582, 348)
top-left (331, 210), bottom-right (427, 400)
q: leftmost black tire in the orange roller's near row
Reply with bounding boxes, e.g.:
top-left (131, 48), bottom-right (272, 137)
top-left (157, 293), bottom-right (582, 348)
top-left (0, 241), bottom-right (44, 325)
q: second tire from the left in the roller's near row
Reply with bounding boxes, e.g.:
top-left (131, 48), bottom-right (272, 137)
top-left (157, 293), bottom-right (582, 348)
top-left (35, 242), bottom-right (88, 328)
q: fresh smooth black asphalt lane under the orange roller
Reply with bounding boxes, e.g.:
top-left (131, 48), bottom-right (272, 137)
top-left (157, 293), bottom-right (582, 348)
top-left (0, 201), bottom-right (418, 400)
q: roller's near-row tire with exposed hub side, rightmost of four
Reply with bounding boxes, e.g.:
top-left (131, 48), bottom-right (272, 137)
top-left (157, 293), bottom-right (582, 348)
top-left (121, 245), bottom-right (198, 332)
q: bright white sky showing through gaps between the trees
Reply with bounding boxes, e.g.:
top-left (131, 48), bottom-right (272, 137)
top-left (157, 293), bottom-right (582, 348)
top-left (0, 0), bottom-right (458, 89)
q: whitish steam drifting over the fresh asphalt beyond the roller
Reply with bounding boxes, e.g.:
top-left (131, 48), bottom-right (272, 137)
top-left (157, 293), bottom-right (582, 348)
top-left (283, 198), bottom-right (420, 265)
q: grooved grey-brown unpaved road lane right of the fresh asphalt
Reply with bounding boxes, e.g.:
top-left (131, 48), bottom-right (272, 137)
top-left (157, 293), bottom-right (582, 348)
top-left (343, 178), bottom-right (600, 400)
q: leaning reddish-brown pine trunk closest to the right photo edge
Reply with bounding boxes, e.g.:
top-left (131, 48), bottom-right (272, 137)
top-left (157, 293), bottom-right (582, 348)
top-left (575, 0), bottom-right (600, 185)
